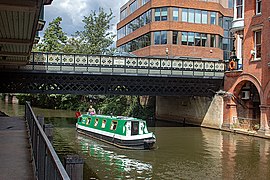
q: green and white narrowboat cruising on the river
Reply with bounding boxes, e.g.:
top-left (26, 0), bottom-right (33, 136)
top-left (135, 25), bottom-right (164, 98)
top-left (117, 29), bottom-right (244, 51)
top-left (76, 114), bottom-right (156, 149)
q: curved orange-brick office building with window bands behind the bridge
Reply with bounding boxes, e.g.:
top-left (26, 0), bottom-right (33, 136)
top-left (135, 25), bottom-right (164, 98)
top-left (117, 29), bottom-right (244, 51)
top-left (117, 0), bottom-right (233, 60)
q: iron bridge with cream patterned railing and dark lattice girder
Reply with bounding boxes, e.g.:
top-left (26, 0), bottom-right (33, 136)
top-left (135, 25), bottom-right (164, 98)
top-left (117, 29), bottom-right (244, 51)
top-left (0, 52), bottom-right (225, 96)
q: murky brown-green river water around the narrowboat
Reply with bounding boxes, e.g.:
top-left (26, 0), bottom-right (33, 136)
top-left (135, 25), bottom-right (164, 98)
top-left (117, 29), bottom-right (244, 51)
top-left (0, 102), bottom-right (270, 180)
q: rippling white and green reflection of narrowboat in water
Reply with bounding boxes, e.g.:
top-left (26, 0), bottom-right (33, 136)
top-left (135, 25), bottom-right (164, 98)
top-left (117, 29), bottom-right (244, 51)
top-left (76, 133), bottom-right (152, 179)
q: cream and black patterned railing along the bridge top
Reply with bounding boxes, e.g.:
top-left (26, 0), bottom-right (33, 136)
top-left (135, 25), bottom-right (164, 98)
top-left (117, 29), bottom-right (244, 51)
top-left (21, 52), bottom-right (225, 77)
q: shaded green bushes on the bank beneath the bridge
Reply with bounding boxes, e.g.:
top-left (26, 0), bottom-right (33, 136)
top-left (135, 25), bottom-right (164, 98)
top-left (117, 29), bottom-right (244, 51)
top-left (13, 94), bottom-right (155, 119)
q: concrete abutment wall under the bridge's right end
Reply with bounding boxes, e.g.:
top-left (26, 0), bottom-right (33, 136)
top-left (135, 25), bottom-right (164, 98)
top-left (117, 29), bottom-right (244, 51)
top-left (156, 95), bottom-right (224, 129)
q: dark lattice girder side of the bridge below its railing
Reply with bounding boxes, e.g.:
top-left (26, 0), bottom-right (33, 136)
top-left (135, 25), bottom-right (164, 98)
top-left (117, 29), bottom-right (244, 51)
top-left (0, 71), bottom-right (223, 96)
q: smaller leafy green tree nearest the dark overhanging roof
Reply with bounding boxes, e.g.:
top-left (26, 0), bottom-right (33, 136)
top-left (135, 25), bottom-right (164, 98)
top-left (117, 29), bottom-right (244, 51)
top-left (35, 16), bottom-right (68, 52)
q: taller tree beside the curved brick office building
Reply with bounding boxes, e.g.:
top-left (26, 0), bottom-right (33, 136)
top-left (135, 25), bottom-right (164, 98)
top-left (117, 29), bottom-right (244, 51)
top-left (65, 8), bottom-right (115, 54)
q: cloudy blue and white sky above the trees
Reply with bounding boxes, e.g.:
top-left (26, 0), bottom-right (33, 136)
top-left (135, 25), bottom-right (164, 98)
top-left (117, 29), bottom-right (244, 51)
top-left (41, 0), bottom-right (128, 41)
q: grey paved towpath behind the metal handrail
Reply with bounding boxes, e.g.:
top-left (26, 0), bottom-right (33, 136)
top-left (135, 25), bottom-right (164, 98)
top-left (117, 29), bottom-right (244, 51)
top-left (0, 112), bottom-right (34, 180)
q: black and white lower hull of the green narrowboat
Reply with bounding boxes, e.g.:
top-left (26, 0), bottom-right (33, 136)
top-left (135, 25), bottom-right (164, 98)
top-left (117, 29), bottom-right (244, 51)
top-left (77, 127), bottom-right (156, 150)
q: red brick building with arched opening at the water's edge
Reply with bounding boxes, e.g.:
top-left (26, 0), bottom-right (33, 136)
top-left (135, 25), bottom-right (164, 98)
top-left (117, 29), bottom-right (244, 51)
top-left (224, 0), bottom-right (270, 132)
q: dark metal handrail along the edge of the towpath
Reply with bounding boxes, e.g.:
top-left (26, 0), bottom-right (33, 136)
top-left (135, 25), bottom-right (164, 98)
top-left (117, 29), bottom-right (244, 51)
top-left (25, 102), bottom-right (70, 180)
